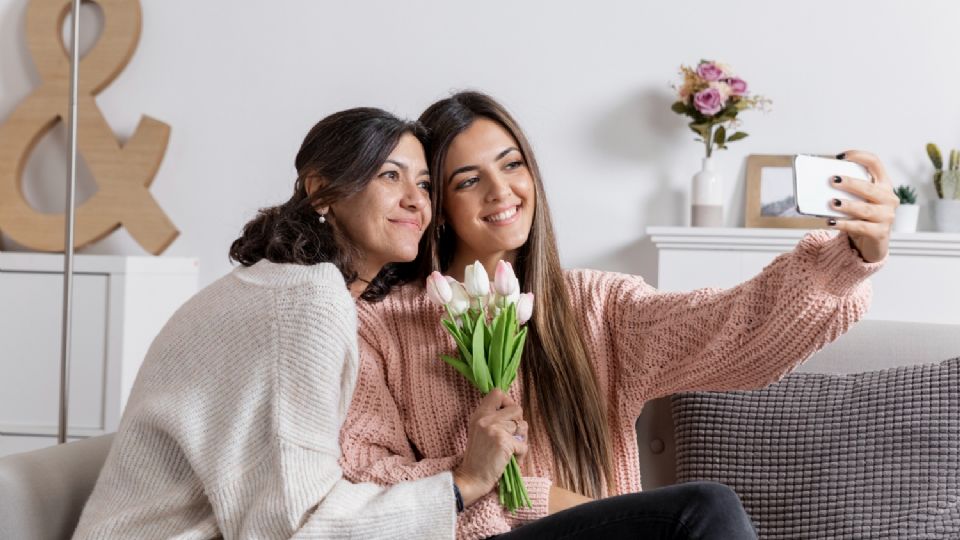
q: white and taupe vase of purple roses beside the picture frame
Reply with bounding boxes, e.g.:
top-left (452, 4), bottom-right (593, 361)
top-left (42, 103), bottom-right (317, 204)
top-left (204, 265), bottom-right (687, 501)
top-left (671, 60), bottom-right (770, 227)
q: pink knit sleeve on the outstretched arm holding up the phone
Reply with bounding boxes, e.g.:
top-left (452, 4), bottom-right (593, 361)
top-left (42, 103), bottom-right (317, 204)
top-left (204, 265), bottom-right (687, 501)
top-left (600, 231), bottom-right (883, 414)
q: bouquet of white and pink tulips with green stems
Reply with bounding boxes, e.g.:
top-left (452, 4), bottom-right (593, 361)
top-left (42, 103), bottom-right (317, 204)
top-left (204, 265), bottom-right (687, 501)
top-left (427, 261), bottom-right (533, 512)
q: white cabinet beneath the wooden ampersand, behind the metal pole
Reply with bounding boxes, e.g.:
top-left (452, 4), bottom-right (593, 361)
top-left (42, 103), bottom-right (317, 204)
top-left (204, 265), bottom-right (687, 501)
top-left (0, 252), bottom-right (197, 456)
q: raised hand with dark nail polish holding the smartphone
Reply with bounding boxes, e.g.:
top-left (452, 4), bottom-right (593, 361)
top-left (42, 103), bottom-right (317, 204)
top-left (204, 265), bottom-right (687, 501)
top-left (828, 150), bottom-right (900, 262)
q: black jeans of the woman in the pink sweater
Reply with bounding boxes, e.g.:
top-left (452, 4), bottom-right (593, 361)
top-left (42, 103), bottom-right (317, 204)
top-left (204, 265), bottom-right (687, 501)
top-left (495, 482), bottom-right (757, 540)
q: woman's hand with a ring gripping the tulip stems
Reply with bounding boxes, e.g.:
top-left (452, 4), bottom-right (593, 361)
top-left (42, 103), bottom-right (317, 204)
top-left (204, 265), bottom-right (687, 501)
top-left (453, 388), bottom-right (528, 506)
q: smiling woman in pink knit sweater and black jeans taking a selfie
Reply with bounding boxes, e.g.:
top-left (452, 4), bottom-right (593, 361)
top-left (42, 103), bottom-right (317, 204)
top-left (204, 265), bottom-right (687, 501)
top-left (341, 93), bottom-right (896, 539)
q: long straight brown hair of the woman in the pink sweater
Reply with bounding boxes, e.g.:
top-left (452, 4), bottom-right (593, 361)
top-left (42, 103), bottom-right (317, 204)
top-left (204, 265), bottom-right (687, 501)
top-left (419, 92), bottom-right (612, 498)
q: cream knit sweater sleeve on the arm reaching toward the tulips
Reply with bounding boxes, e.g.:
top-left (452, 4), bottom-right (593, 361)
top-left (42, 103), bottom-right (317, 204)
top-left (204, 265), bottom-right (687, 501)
top-left (205, 284), bottom-right (455, 539)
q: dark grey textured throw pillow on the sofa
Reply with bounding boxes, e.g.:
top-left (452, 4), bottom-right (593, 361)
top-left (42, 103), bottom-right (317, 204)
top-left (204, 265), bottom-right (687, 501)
top-left (672, 358), bottom-right (960, 540)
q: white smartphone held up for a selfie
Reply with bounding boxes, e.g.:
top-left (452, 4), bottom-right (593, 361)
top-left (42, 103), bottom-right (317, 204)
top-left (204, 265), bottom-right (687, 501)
top-left (793, 154), bottom-right (872, 219)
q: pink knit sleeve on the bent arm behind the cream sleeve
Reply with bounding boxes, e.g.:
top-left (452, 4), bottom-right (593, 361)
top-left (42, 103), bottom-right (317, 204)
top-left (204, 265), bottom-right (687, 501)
top-left (340, 333), bottom-right (551, 539)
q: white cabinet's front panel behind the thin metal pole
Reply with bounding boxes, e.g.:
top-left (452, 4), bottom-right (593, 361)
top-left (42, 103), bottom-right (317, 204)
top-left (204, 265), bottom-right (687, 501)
top-left (0, 272), bottom-right (109, 434)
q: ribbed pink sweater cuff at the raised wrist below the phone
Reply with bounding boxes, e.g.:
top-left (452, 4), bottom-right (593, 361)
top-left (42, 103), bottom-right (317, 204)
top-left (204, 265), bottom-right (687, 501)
top-left (802, 231), bottom-right (889, 297)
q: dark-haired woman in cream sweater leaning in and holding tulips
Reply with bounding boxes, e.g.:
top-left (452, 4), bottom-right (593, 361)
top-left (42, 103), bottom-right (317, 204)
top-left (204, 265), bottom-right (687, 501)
top-left (75, 108), bottom-right (526, 539)
